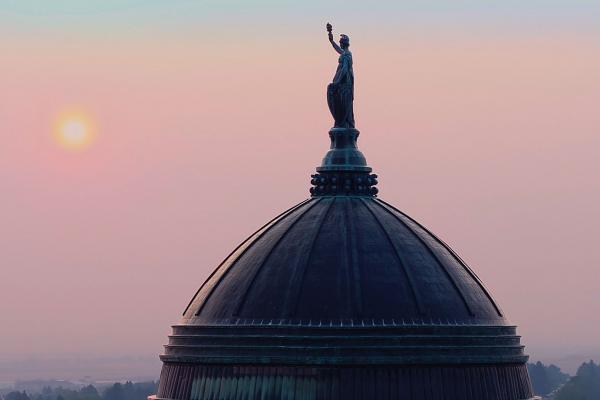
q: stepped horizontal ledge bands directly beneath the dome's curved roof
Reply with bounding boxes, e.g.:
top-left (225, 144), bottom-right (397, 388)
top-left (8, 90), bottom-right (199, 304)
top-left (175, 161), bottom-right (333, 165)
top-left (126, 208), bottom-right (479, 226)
top-left (160, 325), bottom-right (528, 366)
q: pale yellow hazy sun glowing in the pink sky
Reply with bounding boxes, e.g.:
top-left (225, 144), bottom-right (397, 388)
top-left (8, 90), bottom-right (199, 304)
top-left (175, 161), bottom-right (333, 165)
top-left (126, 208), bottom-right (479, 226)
top-left (54, 112), bottom-right (95, 150)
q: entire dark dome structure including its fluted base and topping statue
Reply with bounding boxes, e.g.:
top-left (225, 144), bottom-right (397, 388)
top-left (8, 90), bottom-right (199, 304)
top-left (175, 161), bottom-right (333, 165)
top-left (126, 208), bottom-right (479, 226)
top-left (153, 25), bottom-right (533, 400)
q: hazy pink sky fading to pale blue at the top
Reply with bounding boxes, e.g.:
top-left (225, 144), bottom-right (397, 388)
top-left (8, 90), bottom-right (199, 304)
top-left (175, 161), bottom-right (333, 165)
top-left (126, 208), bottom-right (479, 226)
top-left (0, 0), bottom-right (600, 380)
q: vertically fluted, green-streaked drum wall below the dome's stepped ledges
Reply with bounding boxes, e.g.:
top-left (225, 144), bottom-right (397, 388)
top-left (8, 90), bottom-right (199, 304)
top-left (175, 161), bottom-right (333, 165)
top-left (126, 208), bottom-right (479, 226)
top-left (152, 363), bottom-right (536, 400)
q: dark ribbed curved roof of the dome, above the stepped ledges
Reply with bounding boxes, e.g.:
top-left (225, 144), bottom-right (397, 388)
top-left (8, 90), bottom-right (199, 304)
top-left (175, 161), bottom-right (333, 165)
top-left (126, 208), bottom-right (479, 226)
top-left (182, 196), bottom-right (506, 325)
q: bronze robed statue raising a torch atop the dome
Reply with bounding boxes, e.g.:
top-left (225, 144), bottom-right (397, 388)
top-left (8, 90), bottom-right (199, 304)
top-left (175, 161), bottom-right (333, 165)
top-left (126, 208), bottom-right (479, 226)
top-left (327, 23), bottom-right (354, 128)
